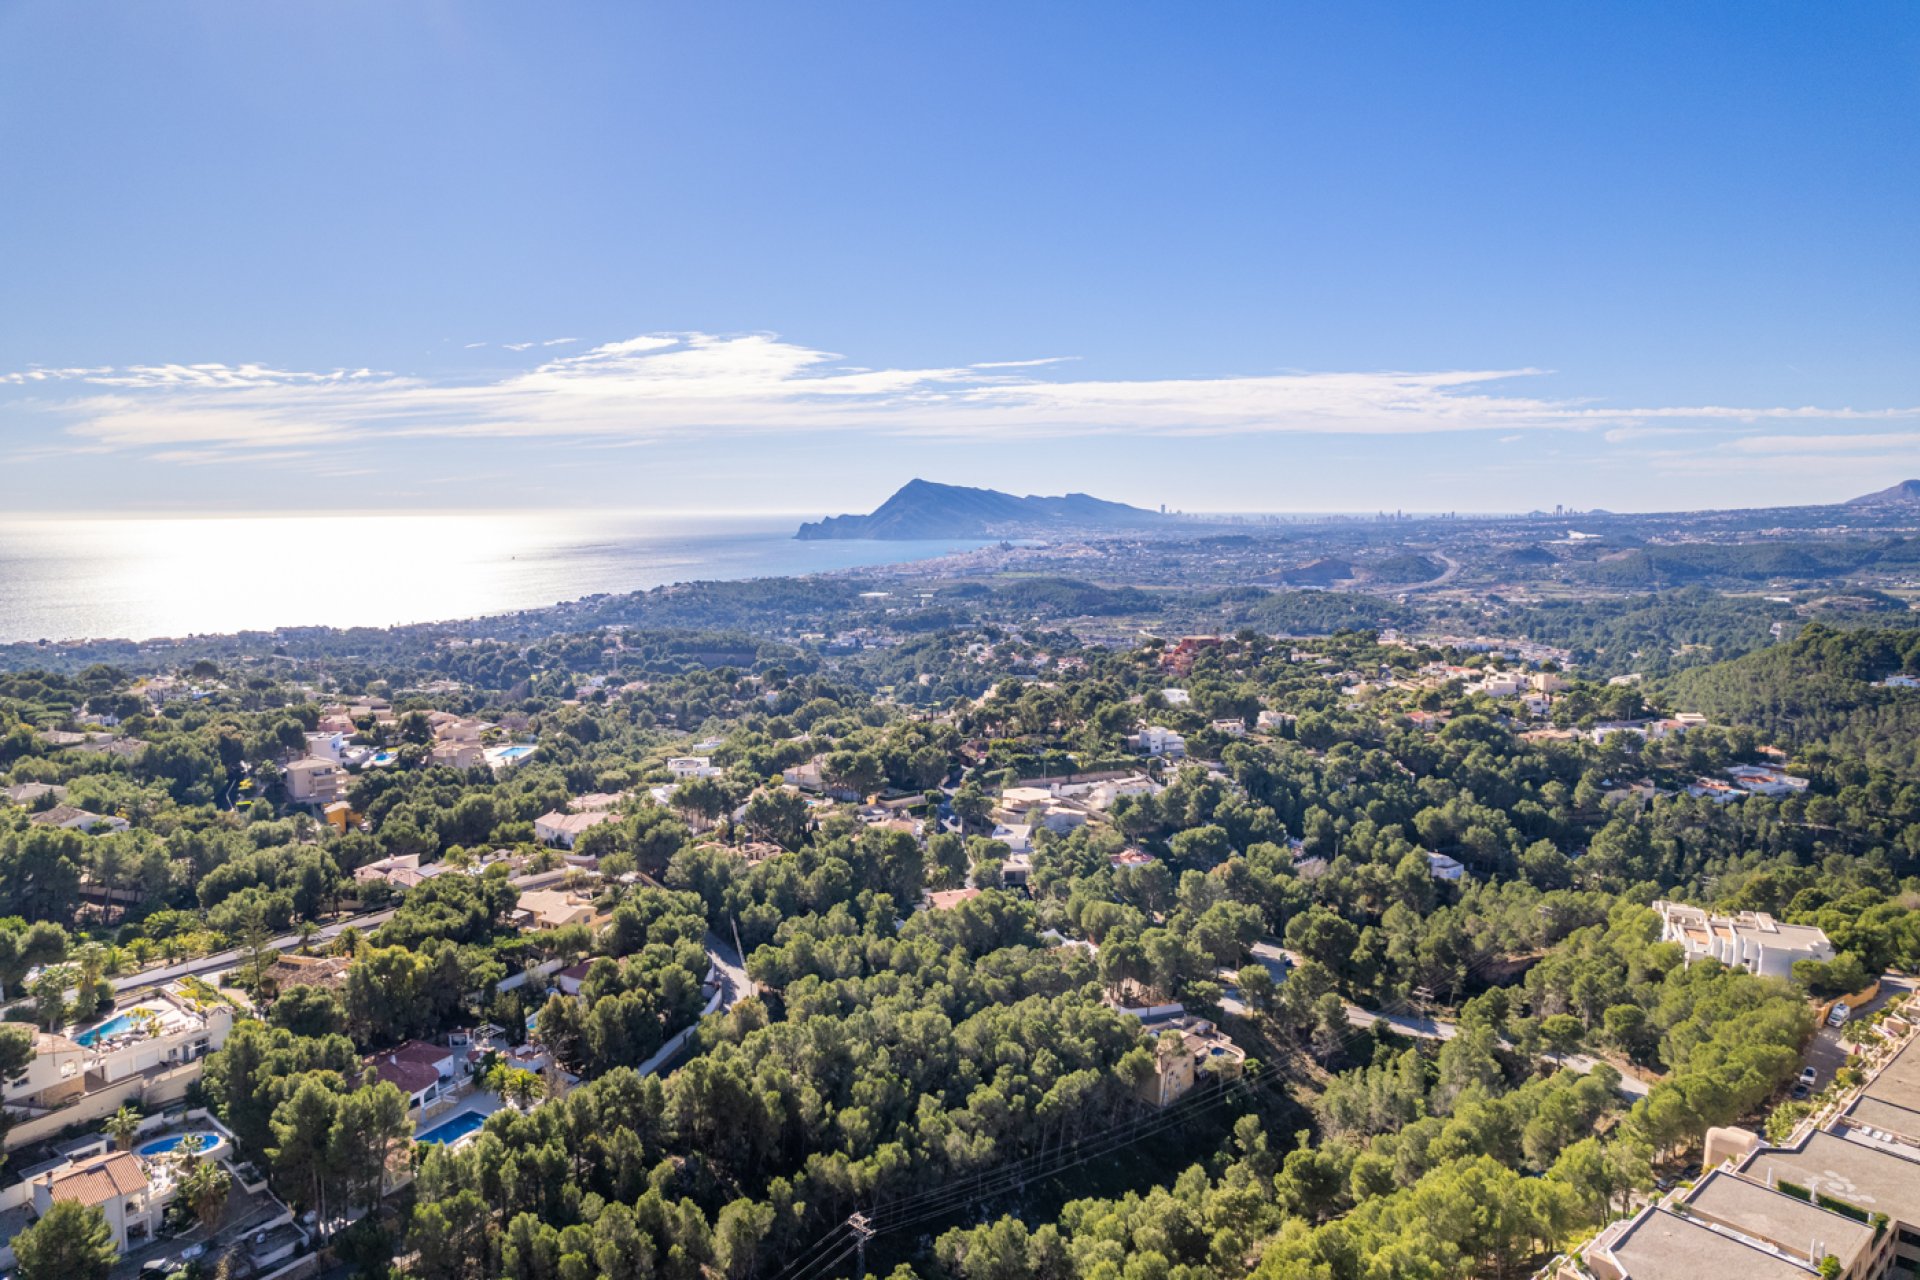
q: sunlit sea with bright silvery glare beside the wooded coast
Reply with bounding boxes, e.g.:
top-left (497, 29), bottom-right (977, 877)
top-left (0, 512), bottom-right (983, 643)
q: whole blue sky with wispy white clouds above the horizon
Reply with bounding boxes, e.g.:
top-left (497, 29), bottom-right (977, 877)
top-left (0, 0), bottom-right (1920, 512)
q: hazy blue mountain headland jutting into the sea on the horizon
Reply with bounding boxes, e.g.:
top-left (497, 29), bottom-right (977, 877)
top-left (795, 480), bottom-right (1173, 541)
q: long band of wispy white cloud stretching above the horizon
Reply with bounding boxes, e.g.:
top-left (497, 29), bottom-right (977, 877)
top-left (15, 334), bottom-right (1920, 461)
